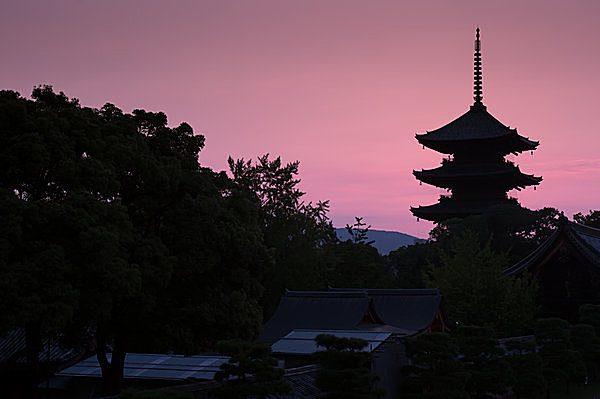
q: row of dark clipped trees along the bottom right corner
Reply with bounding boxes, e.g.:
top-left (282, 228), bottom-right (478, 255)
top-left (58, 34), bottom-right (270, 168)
top-left (402, 306), bottom-right (600, 399)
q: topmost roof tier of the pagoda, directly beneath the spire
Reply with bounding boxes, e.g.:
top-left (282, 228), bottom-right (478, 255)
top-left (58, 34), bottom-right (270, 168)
top-left (416, 103), bottom-right (539, 155)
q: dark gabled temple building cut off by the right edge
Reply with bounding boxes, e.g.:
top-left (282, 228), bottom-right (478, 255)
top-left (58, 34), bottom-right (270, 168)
top-left (504, 220), bottom-right (600, 323)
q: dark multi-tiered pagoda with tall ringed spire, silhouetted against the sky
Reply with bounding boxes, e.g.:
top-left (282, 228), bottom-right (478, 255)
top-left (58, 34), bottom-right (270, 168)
top-left (410, 28), bottom-right (542, 222)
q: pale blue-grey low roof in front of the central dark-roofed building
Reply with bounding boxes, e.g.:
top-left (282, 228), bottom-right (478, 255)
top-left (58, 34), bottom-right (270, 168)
top-left (271, 329), bottom-right (392, 355)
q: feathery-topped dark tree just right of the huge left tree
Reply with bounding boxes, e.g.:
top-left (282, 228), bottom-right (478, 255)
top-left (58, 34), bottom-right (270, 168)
top-left (229, 154), bottom-right (337, 318)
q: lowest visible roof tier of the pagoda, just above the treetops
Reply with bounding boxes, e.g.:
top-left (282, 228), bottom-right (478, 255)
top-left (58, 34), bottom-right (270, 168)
top-left (410, 197), bottom-right (519, 222)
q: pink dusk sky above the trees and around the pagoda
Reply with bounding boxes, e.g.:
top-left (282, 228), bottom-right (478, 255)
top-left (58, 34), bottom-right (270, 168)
top-left (0, 0), bottom-right (600, 237)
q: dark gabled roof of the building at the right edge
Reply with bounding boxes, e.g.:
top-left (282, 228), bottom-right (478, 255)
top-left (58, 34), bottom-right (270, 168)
top-left (504, 221), bottom-right (600, 276)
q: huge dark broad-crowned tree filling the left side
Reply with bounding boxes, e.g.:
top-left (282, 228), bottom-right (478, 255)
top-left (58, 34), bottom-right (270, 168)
top-left (0, 86), bottom-right (271, 393)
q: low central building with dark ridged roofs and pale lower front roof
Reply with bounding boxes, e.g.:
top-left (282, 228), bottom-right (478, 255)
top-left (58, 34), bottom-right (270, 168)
top-left (259, 287), bottom-right (448, 399)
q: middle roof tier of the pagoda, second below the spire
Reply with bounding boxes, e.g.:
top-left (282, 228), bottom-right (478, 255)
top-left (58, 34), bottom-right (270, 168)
top-left (413, 162), bottom-right (542, 190)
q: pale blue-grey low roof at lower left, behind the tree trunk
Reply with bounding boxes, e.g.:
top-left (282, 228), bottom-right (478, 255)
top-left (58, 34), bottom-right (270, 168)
top-left (56, 353), bottom-right (229, 380)
